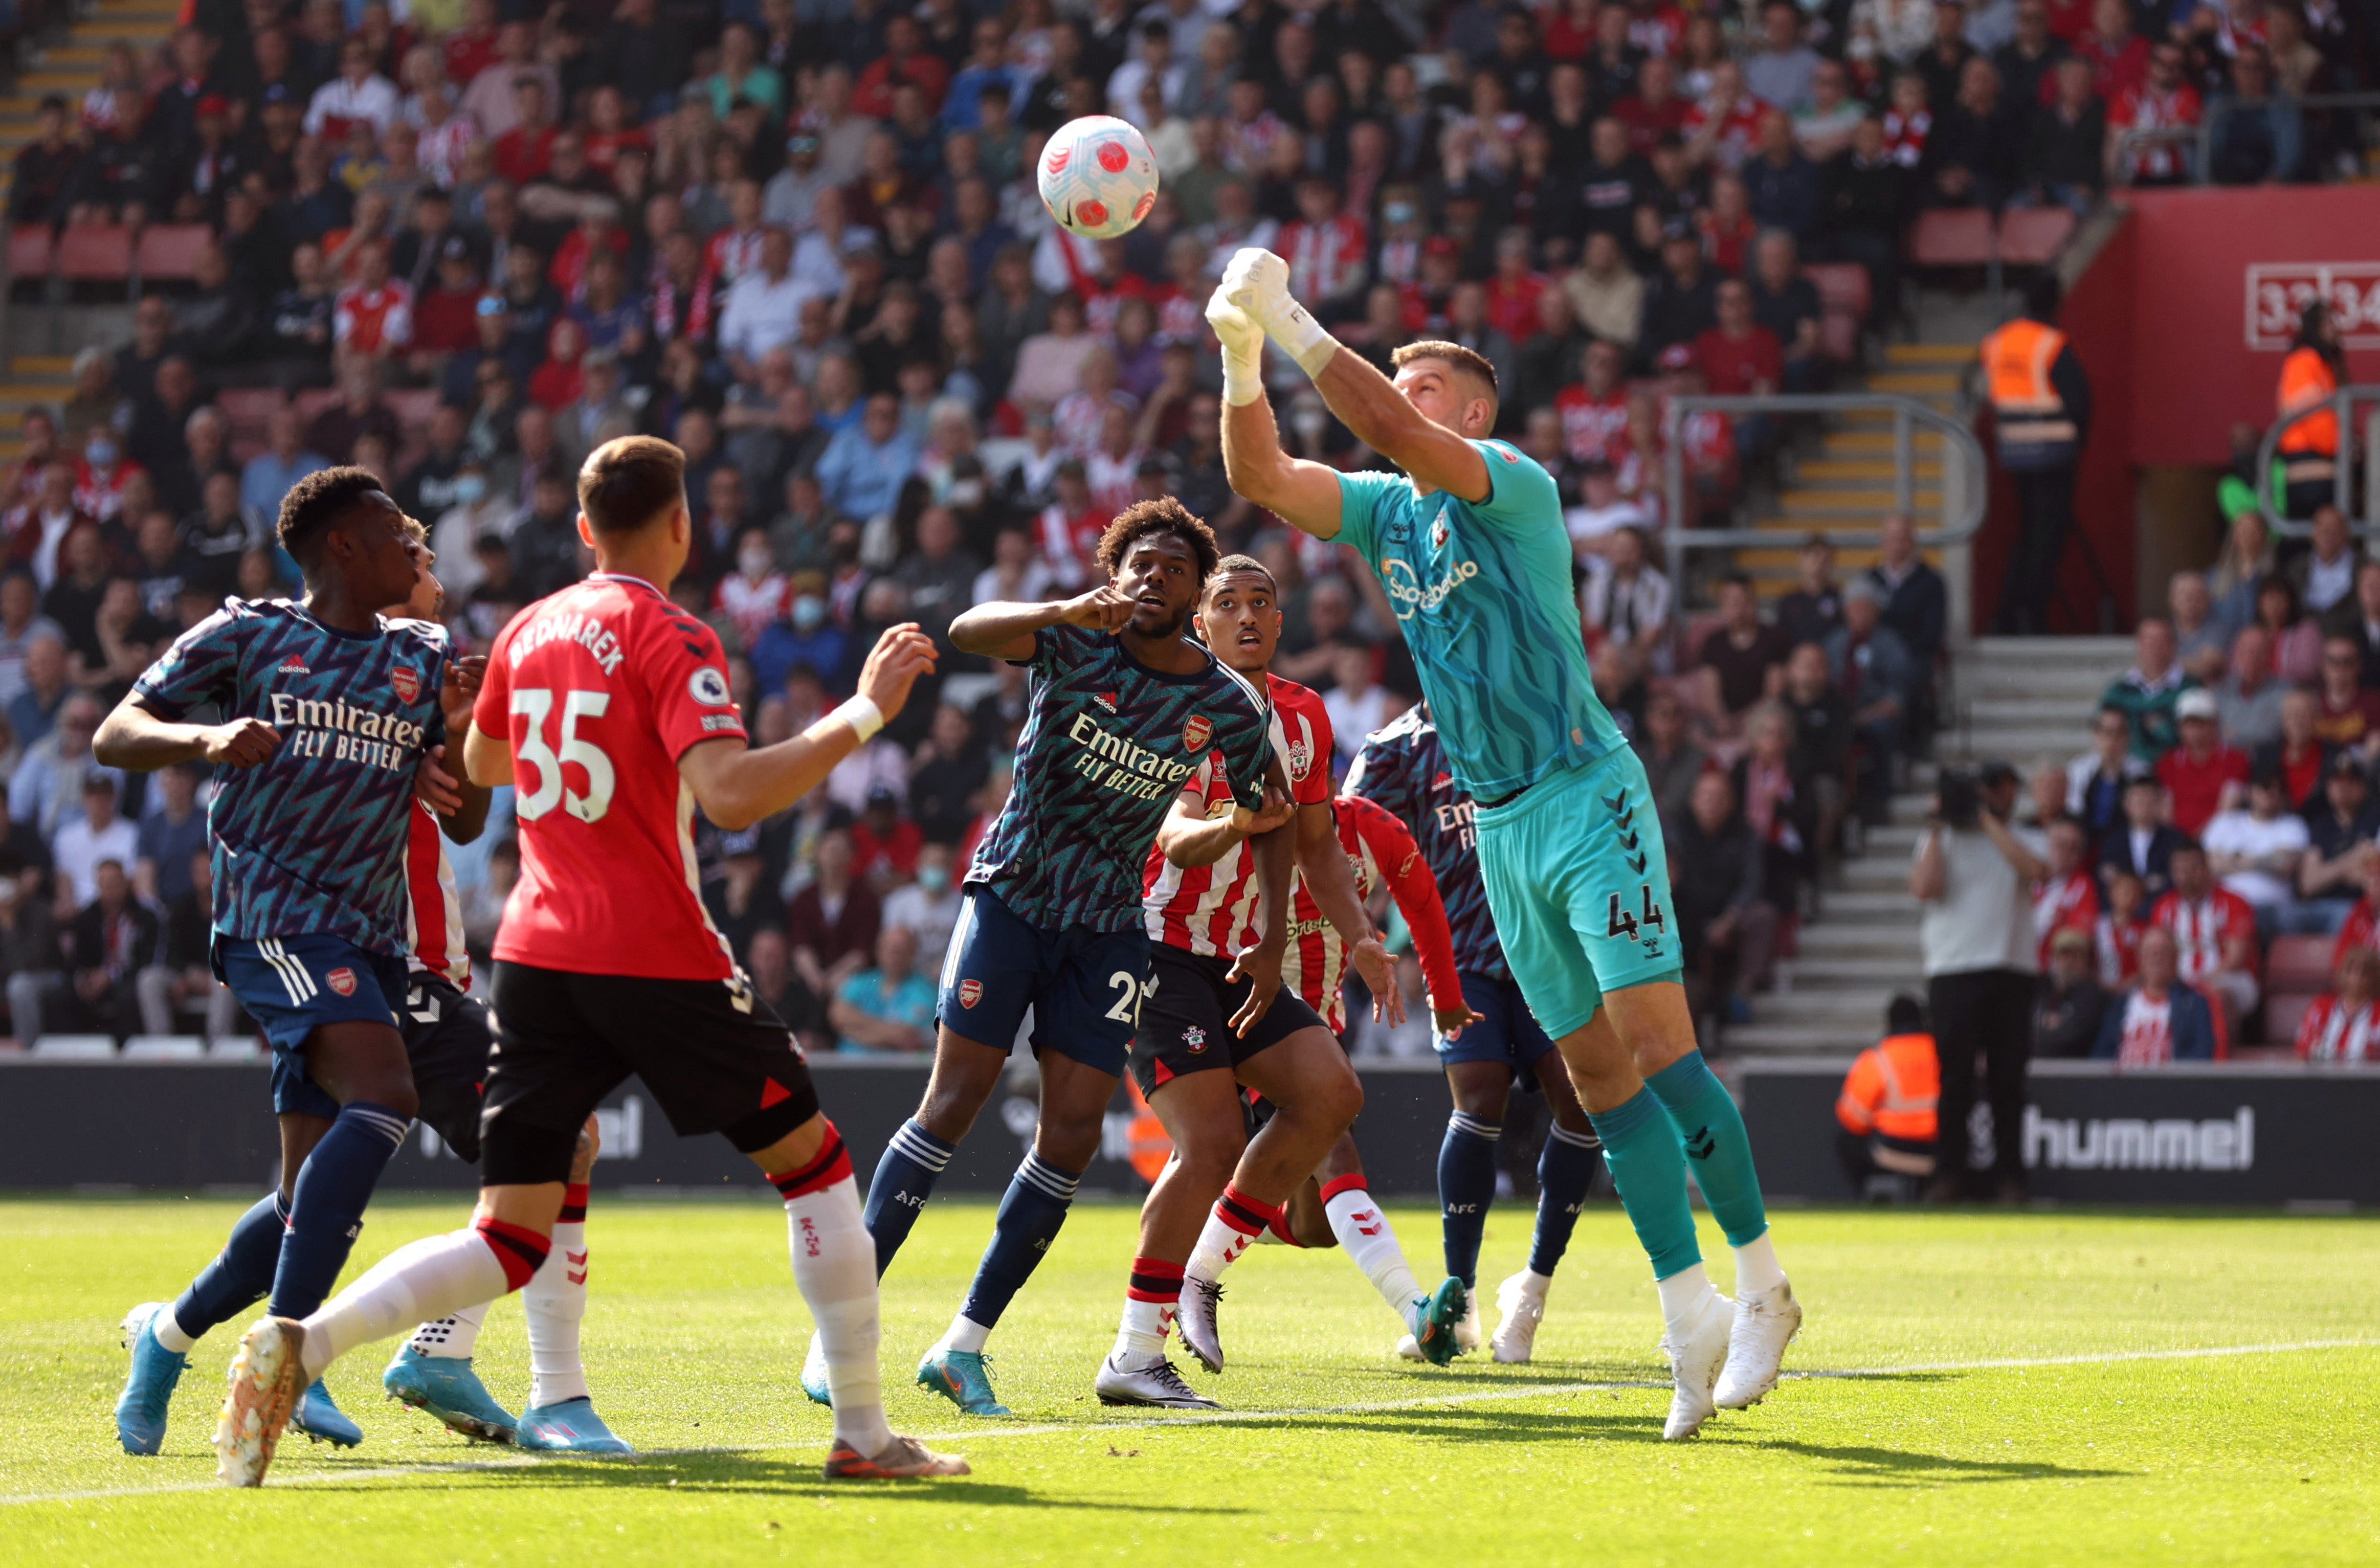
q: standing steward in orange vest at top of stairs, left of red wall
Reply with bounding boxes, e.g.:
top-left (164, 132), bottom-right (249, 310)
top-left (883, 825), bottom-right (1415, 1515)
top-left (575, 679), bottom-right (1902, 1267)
top-left (1975, 274), bottom-right (2089, 635)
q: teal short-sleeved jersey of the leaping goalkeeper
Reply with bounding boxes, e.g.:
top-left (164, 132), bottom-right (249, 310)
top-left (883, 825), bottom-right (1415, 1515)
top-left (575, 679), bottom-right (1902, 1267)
top-left (1338, 440), bottom-right (1628, 802)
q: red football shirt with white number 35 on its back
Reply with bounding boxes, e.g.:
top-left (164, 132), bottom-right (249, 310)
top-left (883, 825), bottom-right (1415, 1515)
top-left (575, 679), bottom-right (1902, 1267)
top-left (471, 573), bottom-right (745, 980)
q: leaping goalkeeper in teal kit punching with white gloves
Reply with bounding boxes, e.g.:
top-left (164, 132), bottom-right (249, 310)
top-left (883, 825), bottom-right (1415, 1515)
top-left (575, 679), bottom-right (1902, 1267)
top-left (1207, 250), bottom-right (1801, 1437)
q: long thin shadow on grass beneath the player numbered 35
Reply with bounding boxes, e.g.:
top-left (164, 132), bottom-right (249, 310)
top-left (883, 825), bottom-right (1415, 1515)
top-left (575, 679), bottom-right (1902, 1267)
top-left (307, 1444), bottom-right (1252, 1518)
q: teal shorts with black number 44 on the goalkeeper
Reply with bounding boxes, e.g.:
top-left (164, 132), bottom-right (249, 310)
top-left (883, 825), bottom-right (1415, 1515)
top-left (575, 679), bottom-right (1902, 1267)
top-left (1473, 747), bottom-right (1683, 1040)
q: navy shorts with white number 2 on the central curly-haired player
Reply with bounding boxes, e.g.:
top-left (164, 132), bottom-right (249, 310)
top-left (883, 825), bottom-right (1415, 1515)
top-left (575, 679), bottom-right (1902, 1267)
top-left (933, 883), bottom-right (1149, 1078)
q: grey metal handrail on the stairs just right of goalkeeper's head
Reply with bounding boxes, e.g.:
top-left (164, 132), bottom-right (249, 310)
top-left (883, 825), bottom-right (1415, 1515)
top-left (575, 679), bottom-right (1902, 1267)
top-left (1661, 393), bottom-right (1990, 642)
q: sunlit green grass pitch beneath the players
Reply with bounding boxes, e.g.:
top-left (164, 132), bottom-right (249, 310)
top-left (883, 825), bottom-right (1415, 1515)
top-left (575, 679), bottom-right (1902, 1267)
top-left (0, 1190), bottom-right (2380, 1568)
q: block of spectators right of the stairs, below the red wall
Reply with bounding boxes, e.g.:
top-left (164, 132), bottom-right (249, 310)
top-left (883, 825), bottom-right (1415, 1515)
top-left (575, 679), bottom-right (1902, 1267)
top-left (2033, 528), bottom-right (2380, 1064)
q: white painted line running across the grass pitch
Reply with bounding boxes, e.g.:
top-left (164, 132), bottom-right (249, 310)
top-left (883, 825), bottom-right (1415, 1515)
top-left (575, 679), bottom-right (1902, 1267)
top-left (0, 1339), bottom-right (2380, 1506)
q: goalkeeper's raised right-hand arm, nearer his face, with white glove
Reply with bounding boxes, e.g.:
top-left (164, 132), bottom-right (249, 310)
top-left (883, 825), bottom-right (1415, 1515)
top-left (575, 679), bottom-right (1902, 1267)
top-left (1207, 248), bottom-right (1490, 502)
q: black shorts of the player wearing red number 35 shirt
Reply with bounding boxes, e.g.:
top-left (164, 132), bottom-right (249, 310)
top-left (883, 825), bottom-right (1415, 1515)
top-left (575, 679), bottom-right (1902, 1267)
top-left (481, 961), bottom-right (819, 1182)
